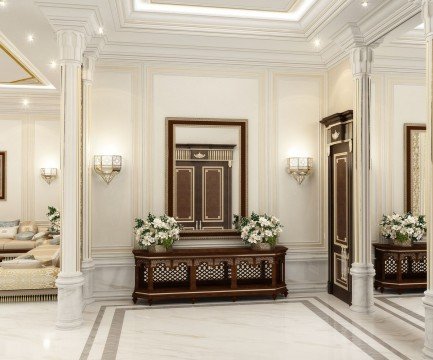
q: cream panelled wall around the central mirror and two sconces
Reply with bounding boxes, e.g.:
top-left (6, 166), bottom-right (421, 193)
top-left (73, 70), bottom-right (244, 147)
top-left (91, 63), bottom-right (327, 299)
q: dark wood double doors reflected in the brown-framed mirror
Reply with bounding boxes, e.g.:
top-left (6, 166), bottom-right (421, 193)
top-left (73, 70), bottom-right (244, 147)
top-left (175, 161), bottom-right (232, 230)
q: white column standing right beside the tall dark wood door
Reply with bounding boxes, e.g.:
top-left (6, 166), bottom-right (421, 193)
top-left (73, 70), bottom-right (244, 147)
top-left (350, 46), bottom-right (375, 313)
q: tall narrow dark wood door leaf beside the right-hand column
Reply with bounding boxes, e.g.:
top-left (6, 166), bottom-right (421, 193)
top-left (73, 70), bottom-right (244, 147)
top-left (328, 141), bottom-right (352, 304)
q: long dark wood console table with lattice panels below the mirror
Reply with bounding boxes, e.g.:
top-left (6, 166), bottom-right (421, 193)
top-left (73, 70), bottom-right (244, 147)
top-left (132, 246), bottom-right (288, 305)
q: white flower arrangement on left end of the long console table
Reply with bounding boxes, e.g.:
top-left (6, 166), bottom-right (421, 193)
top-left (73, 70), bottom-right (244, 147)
top-left (134, 213), bottom-right (182, 248)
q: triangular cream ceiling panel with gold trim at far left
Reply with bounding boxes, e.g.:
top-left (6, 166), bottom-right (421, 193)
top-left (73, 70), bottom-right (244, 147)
top-left (0, 43), bottom-right (42, 85)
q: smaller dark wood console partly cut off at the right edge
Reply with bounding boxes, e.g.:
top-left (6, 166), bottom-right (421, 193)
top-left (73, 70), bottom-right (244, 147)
top-left (373, 244), bottom-right (427, 294)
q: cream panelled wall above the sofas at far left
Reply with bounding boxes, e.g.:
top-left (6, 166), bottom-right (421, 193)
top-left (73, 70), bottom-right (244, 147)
top-left (0, 114), bottom-right (60, 223)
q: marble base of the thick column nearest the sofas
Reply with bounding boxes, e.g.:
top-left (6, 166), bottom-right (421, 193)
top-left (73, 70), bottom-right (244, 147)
top-left (56, 272), bottom-right (84, 330)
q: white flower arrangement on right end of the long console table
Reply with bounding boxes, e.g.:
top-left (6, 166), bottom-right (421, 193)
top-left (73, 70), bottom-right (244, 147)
top-left (233, 212), bottom-right (283, 246)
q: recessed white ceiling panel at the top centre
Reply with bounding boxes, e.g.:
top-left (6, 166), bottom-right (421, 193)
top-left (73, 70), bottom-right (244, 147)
top-left (149, 0), bottom-right (297, 12)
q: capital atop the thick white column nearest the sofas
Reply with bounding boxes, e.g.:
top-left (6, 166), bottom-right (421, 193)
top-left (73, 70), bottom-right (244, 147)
top-left (57, 30), bottom-right (86, 64)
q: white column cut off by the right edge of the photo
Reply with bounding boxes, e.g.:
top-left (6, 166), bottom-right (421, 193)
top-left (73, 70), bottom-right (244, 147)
top-left (422, 0), bottom-right (433, 359)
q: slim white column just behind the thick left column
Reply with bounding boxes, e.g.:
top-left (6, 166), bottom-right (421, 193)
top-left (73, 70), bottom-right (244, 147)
top-left (81, 55), bottom-right (96, 304)
